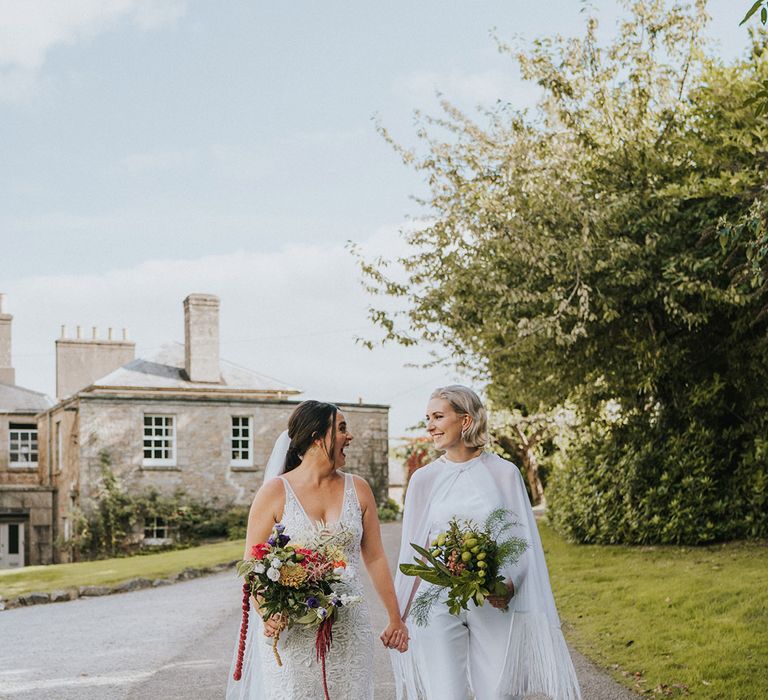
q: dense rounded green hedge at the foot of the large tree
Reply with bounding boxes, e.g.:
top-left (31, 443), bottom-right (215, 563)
top-left (547, 417), bottom-right (768, 544)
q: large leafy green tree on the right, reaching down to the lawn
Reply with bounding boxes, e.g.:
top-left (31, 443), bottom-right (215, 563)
top-left (362, 0), bottom-right (768, 542)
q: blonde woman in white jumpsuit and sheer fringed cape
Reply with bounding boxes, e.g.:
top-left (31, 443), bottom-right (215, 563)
top-left (392, 385), bottom-right (581, 700)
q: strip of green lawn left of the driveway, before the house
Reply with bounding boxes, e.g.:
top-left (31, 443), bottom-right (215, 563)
top-left (0, 540), bottom-right (244, 598)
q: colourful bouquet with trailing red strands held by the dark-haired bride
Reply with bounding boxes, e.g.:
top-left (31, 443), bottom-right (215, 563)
top-left (234, 523), bottom-right (360, 698)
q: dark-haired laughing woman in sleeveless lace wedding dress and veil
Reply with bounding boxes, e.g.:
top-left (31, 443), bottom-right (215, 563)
top-left (227, 401), bottom-right (408, 700)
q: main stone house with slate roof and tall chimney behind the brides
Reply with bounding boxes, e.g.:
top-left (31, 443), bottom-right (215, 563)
top-left (0, 294), bottom-right (388, 563)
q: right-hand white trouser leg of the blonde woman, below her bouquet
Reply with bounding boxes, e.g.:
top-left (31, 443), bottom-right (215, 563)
top-left (466, 602), bottom-right (520, 700)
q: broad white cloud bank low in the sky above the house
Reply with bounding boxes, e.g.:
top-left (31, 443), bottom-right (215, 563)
top-left (2, 227), bottom-right (462, 435)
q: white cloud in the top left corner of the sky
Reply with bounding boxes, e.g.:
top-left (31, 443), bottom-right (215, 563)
top-left (0, 0), bottom-right (186, 101)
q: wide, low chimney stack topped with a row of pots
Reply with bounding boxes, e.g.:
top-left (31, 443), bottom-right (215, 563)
top-left (56, 326), bottom-right (136, 399)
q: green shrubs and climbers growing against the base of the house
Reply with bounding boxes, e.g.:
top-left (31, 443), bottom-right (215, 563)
top-left (68, 450), bottom-right (248, 559)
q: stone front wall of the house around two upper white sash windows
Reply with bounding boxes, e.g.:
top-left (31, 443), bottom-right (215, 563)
top-left (73, 396), bottom-right (388, 508)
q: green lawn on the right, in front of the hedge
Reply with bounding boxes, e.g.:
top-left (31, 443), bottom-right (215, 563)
top-left (540, 525), bottom-right (768, 700)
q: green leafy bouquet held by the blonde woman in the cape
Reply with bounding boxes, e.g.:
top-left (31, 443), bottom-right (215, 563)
top-left (400, 508), bottom-right (528, 627)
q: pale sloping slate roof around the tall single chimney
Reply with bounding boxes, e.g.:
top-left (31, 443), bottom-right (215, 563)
top-left (85, 343), bottom-right (301, 394)
